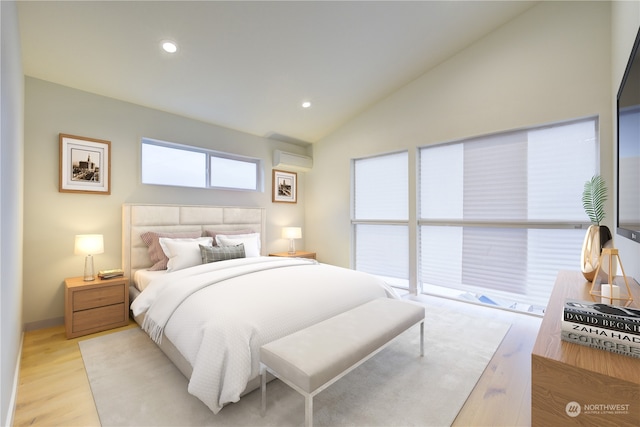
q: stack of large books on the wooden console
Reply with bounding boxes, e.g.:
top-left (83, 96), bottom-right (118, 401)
top-left (562, 299), bottom-right (640, 358)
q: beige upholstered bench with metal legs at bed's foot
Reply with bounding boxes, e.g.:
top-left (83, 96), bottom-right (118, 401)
top-left (260, 298), bottom-right (425, 427)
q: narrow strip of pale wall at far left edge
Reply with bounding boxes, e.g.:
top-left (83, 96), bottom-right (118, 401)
top-left (0, 1), bottom-right (24, 425)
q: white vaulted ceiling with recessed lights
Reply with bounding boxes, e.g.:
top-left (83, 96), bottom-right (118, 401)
top-left (18, 1), bottom-right (536, 143)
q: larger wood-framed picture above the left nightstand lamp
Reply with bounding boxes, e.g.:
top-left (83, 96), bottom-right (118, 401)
top-left (58, 133), bottom-right (111, 194)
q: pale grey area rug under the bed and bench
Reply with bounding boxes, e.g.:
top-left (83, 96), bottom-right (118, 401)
top-left (80, 307), bottom-right (510, 427)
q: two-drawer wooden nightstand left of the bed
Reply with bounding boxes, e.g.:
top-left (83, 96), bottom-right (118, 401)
top-left (64, 277), bottom-right (129, 338)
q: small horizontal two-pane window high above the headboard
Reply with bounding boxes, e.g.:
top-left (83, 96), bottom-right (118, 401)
top-left (142, 138), bottom-right (262, 191)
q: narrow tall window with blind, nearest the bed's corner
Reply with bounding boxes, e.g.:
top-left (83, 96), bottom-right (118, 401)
top-left (352, 151), bottom-right (409, 288)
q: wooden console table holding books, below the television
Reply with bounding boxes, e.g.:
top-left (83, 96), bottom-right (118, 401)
top-left (531, 271), bottom-right (640, 427)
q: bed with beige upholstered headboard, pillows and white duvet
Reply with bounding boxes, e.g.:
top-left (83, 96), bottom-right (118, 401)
top-left (122, 204), bottom-right (397, 413)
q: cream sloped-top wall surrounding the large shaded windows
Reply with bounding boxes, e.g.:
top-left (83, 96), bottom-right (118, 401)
top-left (306, 2), bottom-right (614, 280)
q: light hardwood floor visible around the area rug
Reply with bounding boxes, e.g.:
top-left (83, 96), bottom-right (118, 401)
top-left (14, 295), bottom-right (541, 427)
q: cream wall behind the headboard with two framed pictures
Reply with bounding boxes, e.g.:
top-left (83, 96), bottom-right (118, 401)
top-left (24, 78), bottom-right (306, 328)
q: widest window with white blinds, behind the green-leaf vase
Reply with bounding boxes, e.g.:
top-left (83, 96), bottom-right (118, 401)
top-left (418, 119), bottom-right (598, 308)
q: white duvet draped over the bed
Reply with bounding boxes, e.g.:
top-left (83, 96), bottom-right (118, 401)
top-left (131, 257), bottom-right (397, 413)
